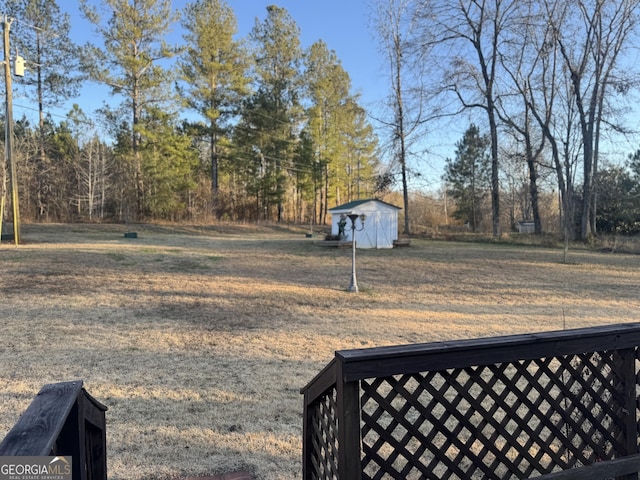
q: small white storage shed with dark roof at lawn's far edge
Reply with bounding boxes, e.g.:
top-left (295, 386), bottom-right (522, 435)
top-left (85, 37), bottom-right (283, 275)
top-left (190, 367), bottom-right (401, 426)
top-left (329, 199), bottom-right (401, 248)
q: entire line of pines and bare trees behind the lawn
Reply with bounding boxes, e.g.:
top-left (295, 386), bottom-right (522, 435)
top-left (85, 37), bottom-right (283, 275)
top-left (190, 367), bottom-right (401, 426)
top-left (7, 0), bottom-right (640, 240)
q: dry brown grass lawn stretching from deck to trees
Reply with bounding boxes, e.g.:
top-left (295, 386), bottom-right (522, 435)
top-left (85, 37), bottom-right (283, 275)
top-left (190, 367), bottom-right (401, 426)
top-left (0, 225), bottom-right (640, 480)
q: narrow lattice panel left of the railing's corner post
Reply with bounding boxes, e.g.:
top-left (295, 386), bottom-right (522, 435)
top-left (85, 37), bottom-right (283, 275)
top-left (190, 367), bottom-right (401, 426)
top-left (311, 387), bottom-right (339, 480)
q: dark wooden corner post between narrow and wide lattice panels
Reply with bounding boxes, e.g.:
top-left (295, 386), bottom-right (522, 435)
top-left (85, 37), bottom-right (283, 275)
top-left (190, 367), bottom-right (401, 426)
top-left (336, 358), bottom-right (362, 480)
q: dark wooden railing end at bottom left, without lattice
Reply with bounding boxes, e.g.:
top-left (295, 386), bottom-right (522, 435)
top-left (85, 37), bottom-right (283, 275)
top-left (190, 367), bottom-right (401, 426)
top-left (0, 380), bottom-right (107, 480)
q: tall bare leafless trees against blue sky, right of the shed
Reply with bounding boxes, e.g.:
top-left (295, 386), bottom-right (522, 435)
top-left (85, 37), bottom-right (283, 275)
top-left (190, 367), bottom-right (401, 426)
top-left (376, 0), bottom-right (640, 240)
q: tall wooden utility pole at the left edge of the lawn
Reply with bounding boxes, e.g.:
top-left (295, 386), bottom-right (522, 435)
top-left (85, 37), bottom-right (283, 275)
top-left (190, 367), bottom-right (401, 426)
top-left (0, 15), bottom-right (20, 245)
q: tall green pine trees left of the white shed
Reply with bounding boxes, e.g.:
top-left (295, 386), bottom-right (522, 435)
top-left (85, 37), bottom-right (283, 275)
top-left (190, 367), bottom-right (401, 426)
top-left (3, 0), bottom-right (379, 223)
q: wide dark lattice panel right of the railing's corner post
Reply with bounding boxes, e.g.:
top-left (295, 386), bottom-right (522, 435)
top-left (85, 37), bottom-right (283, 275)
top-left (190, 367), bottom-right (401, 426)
top-left (361, 352), bottom-right (640, 480)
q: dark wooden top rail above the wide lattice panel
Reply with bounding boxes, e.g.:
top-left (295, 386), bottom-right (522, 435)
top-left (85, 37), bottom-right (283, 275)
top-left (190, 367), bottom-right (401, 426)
top-left (332, 323), bottom-right (640, 382)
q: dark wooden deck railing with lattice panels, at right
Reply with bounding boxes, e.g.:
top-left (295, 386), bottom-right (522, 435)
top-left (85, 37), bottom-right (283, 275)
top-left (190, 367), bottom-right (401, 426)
top-left (301, 323), bottom-right (640, 480)
